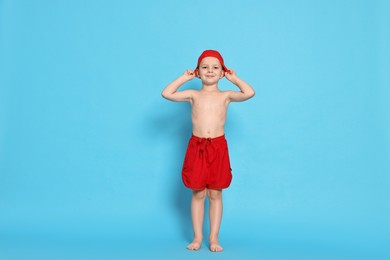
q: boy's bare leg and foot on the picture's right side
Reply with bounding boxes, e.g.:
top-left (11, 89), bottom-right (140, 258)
top-left (208, 190), bottom-right (223, 252)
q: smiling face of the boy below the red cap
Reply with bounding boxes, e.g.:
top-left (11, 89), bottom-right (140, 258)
top-left (198, 57), bottom-right (225, 83)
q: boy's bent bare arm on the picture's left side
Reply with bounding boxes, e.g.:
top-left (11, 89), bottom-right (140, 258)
top-left (161, 70), bottom-right (195, 102)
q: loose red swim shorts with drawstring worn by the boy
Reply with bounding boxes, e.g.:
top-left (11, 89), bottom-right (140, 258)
top-left (182, 135), bottom-right (232, 190)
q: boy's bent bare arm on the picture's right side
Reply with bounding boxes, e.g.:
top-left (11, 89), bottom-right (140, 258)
top-left (225, 69), bottom-right (255, 102)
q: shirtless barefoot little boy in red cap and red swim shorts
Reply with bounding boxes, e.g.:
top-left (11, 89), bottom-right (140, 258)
top-left (162, 50), bottom-right (255, 252)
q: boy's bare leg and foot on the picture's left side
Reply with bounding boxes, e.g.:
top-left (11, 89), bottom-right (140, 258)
top-left (187, 189), bottom-right (206, 250)
